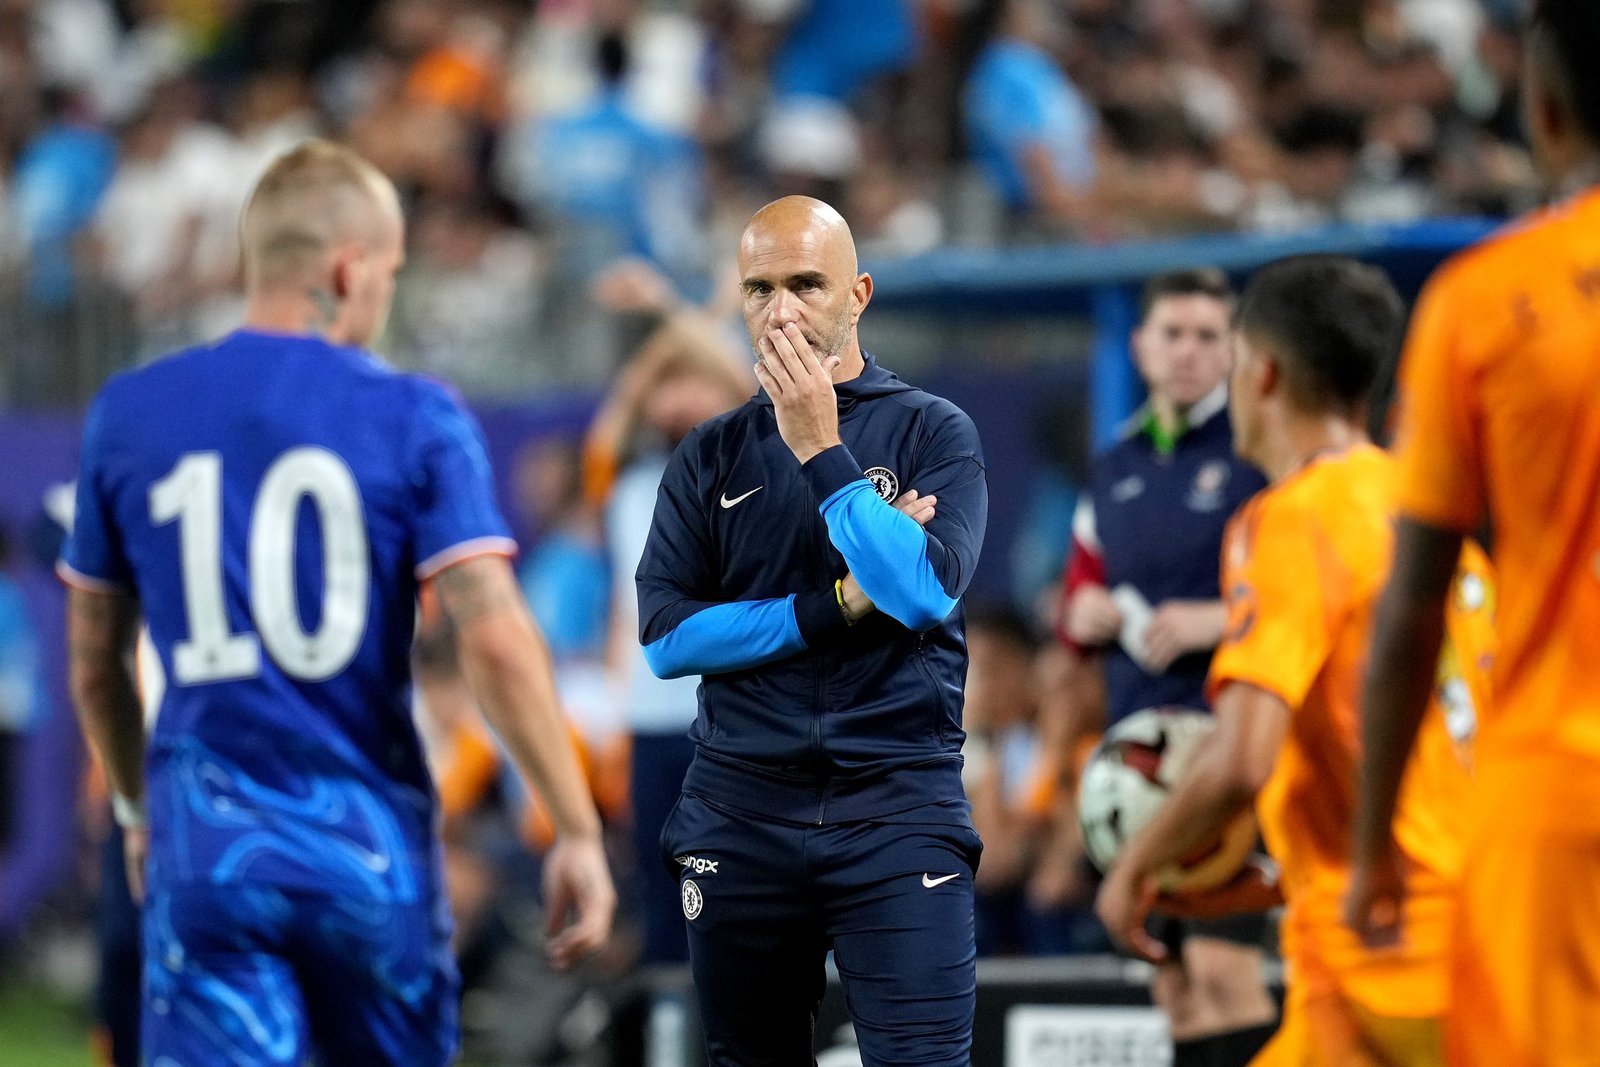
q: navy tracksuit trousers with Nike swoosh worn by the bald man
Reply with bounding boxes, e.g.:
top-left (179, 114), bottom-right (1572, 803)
top-left (661, 793), bottom-right (982, 1067)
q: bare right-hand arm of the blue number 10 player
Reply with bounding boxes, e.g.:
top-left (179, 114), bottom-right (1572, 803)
top-left (429, 553), bottom-right (616, 968)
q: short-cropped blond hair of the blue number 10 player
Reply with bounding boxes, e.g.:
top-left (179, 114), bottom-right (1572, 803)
top-left (240, 138), bottom-right (400, 288)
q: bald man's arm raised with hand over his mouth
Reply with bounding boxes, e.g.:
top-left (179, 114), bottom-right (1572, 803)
top-left (755, 325), bottom-right (989, 630)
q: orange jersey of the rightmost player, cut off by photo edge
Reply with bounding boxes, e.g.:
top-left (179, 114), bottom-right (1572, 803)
top-left (1395, 192), bottom-right (1600, 764)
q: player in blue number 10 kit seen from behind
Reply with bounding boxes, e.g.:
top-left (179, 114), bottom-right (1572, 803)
top-left (59, 141), bottom-right (614, 1067)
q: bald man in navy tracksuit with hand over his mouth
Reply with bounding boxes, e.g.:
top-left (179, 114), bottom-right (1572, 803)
top-left (638, 197), bottom-right (989, 1067)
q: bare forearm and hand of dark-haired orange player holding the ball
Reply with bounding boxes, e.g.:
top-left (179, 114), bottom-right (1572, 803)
top-left (1094, 681), bottom-right (1290, 963)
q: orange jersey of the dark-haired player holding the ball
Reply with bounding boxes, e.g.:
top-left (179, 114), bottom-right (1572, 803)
top-left (1208, 445), bottom-right (1493, 1017)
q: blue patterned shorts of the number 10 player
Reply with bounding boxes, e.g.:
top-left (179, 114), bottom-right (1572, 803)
top-left (141, 885), bottom-right (459, 1067)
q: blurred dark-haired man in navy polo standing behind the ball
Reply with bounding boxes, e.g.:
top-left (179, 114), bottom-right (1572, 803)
top-left (1061, 270), bottom-right (1277, 1067)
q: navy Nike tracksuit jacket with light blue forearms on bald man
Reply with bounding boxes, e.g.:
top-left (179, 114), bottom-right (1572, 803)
top-left (637, 357), bottom-right (989, 825)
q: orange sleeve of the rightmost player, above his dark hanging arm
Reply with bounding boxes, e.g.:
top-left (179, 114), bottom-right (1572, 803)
top-left (1394, 267), bottom-right (1483, 533)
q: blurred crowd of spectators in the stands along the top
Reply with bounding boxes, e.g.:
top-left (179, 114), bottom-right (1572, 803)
top-left (0, 0), bottom-right (1533, 403)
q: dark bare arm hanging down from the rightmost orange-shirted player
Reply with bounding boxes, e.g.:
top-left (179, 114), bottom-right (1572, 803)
top-left (1344, 518), bottom-right (1462, 947)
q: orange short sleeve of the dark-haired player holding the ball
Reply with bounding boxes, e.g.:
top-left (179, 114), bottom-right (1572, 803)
top-left (1206, 496), bottom-right (1344, 707)
